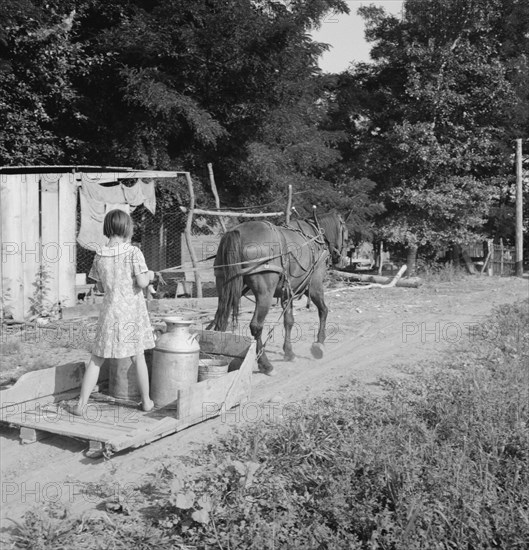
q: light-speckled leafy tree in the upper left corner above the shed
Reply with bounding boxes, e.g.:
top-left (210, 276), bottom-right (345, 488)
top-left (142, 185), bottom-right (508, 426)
top-left (0, 0), bottom-right (84, 165)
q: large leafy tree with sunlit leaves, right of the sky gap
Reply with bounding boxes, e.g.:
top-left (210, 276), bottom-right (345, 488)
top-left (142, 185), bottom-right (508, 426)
top-left (332, 0), bottom-right (520, 274)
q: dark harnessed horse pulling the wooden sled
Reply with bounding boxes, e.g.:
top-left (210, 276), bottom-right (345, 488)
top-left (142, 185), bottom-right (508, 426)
top-left (208, 213), bottom-right (347, 374)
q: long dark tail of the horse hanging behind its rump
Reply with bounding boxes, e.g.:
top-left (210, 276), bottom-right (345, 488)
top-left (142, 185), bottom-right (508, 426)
top-left (214, 229), bottom-right (243, 331)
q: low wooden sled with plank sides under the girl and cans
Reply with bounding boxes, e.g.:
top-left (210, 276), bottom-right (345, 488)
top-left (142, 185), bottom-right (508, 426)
top-left (0, 331), bottom-right (257, 456)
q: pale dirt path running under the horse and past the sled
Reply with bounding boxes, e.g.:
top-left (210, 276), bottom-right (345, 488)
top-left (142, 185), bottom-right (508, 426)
top-left (0, 277), bottom-right (529, 540)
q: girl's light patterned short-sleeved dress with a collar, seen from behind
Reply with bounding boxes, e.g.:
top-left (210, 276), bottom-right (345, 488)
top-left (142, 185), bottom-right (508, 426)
top-left (88, 243), bottom-right (154, 359)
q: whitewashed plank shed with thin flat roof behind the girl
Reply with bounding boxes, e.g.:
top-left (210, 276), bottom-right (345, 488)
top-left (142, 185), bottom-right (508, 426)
top-left (0, 166), bottom-right (185, 321)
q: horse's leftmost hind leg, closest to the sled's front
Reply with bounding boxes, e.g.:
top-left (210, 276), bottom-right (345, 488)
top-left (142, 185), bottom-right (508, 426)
top-left (245, 272), bottom-right (279, 376)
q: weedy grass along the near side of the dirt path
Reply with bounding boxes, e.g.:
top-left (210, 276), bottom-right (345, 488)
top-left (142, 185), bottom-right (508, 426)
top-left (8, 302), bottom-right (529, 550)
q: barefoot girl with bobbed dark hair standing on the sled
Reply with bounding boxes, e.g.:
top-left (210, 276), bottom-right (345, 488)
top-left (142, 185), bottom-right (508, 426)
top-left (70, 210), bottom-right (154, 416)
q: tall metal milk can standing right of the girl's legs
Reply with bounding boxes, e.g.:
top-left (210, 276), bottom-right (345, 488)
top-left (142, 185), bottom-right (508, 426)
top-left (151, 317), bottom-right (200, 407)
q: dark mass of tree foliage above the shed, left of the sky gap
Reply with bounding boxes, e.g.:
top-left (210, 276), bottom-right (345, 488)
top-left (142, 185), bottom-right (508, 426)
top-left (0, 0), bottom-right (364, 213)
